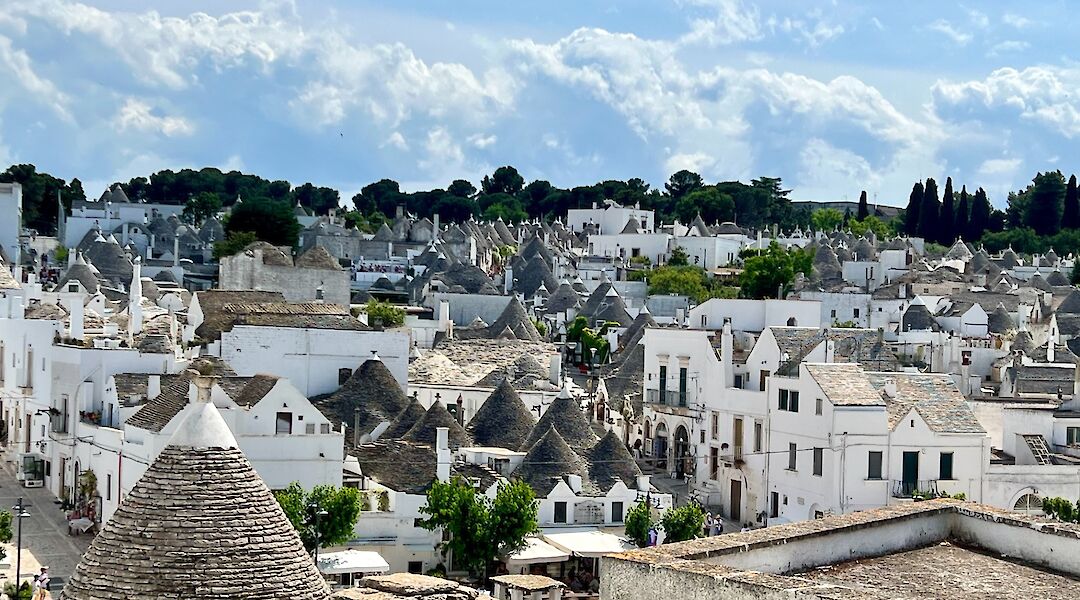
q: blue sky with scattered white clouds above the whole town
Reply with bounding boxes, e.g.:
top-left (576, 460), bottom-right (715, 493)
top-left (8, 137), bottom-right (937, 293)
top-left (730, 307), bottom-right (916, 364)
top-left (0, 0), bottom-right (1080, 205)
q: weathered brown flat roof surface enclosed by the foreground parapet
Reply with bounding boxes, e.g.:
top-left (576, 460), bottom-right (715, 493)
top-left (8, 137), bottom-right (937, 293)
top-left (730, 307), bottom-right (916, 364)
top-left (796, 542), bottom-right (1080, 600)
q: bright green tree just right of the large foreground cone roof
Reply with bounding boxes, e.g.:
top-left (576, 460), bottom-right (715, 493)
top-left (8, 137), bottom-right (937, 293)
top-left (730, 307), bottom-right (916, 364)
top-left (273, 481), bottom-right (361, 551)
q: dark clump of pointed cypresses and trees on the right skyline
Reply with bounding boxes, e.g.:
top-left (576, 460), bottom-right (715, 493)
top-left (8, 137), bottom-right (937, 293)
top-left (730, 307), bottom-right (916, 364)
top-left (903, 171), bottom-right (1080, 254)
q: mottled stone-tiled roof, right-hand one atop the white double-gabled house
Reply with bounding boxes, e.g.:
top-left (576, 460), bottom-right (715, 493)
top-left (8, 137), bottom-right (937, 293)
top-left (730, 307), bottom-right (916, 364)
top-left (867, 373), bottom-right (986, 434)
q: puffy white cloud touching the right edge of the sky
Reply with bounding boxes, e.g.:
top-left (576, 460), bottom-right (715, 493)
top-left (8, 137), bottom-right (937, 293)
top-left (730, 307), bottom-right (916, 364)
top-left (931, 67), bottom-right (1080, 137)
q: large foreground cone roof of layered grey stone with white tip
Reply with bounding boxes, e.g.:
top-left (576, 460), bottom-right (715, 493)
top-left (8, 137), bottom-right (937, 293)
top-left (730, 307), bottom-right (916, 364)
top-left (59, 403), bottom-right (329, 600)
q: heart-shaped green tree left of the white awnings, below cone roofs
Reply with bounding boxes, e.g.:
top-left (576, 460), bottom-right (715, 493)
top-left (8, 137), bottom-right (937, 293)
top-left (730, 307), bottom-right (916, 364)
top-left (420, 477), bottom-right (537, 578)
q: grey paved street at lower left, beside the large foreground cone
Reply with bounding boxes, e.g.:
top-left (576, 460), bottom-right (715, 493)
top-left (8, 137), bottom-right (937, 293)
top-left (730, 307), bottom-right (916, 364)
top-left (0, 462), bottom-right (93, 598)
